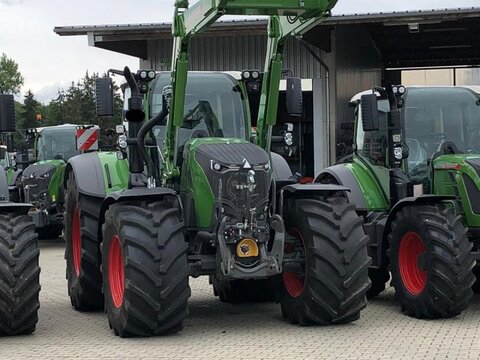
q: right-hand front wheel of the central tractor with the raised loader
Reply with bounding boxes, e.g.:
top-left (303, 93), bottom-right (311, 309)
top-left (280, 197), bottom-right (371, 325)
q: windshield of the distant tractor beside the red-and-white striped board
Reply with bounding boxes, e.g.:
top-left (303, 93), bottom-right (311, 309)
top-left (37, 127), bottom-right (80, 161)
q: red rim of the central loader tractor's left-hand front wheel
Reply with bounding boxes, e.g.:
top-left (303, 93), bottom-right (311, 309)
top-left (108, 235), bottom-right (125, 308)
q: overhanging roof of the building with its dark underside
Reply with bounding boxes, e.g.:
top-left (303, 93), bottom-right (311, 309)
top-left (54, 7), bottom-right (480, 69)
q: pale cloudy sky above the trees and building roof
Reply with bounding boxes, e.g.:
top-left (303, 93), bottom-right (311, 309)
top-left (0, 0), bottom-right (480, 103)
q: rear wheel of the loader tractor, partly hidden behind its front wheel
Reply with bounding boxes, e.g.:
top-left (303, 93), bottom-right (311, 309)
top-left (65, 171), bottom-right (103, 311)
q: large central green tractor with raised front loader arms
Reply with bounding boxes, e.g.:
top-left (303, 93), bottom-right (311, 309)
top-left (65, 0), bottom-right (370, 337)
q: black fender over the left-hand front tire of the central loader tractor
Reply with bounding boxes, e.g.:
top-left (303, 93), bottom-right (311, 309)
top-left (98, 187), bottom-right (183, 231)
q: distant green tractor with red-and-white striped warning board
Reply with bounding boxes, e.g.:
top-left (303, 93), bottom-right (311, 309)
top-left (16, 124), bottom-right (98, 239)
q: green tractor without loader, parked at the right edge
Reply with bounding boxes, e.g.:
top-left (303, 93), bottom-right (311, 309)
top-left (316, 86), bottom-right (480, 318)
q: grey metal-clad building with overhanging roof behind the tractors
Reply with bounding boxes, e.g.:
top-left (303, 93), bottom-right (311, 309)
top-left (55, 8), bottom-right (480, 176)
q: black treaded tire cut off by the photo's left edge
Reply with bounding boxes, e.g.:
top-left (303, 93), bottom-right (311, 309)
top-left (0, 215), bottom-right (40, 335)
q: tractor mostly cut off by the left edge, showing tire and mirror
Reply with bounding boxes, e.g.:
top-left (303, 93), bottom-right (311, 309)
top-left (0, 94), bottom-right (40, 336)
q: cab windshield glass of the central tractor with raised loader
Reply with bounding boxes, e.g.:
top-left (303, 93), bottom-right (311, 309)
top-left (150, 73), bottom-right (247, 145)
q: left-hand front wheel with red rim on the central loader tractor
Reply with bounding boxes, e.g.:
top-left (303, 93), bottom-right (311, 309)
top-left (102, 201), bottom-right (191, 337)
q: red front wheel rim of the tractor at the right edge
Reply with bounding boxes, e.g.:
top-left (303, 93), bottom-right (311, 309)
top-left (398, 231), bottom-right (427, 295)
